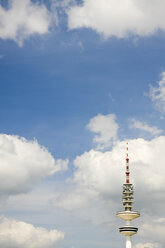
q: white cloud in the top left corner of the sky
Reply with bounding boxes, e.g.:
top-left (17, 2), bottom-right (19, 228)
top-left (0, 0), bottom-right (51, 45)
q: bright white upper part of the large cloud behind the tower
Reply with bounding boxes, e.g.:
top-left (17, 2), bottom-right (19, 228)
top-left (74, 136), bottom-right (165, 209)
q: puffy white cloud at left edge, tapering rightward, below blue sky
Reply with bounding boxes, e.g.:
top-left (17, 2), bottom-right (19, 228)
top-left (0, 134), bottom-right (68, 195)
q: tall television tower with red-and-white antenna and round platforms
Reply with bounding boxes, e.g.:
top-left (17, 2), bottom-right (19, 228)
top-left (116, 143), bottom-right (140, 248)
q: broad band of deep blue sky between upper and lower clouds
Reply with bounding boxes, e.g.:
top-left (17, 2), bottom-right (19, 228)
top-left (0, 28), bottom-right (164, 157)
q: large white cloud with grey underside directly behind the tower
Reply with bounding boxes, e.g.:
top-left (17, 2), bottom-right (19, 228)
top-left (53, 136), bottom-right (165, 230)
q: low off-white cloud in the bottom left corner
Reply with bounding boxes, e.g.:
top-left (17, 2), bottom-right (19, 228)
top-left (0, 217), bottom-right (64, 248)
